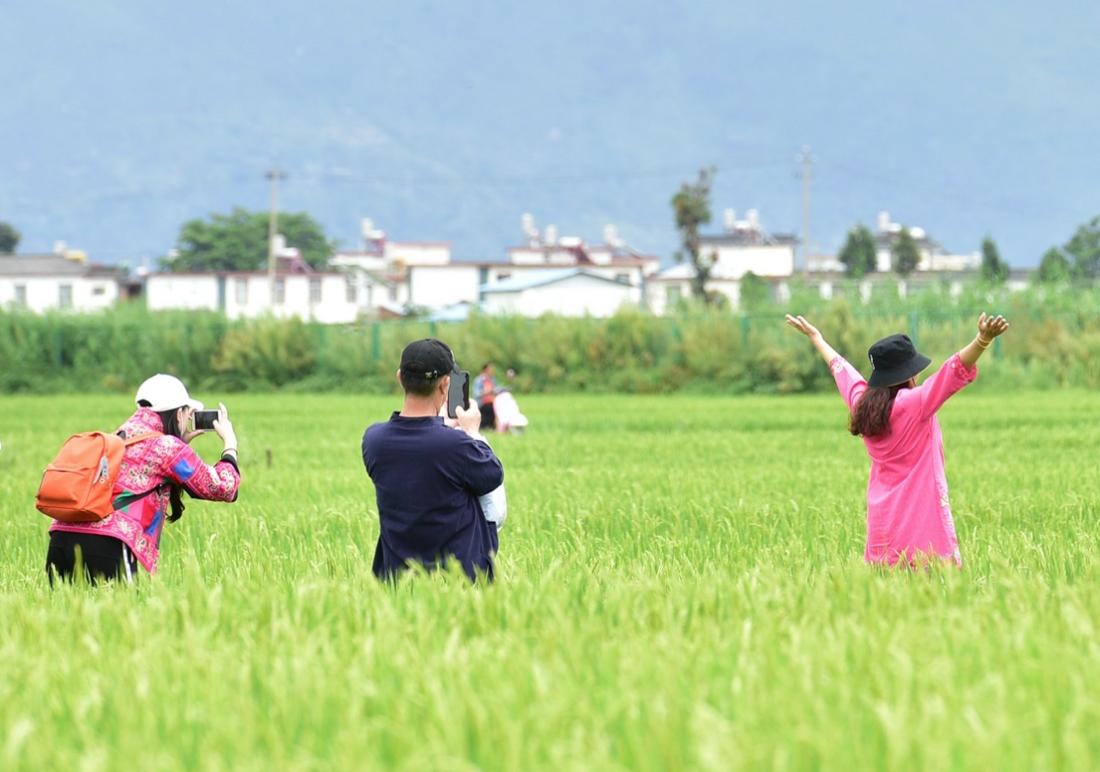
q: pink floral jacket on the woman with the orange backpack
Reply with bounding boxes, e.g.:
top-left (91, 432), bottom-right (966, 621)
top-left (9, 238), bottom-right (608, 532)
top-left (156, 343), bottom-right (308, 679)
top-left (50, 408), bottom-right (241, 574)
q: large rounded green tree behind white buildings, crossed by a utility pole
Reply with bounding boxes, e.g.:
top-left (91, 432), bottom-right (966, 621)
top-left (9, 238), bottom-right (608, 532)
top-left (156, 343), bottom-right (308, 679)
top-left (164, 207), bottom-right (336, 272)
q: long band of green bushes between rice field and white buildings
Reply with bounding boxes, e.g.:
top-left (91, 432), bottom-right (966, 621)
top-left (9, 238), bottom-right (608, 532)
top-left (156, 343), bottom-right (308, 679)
top-left (0, 292), bottom-right (1100, 394)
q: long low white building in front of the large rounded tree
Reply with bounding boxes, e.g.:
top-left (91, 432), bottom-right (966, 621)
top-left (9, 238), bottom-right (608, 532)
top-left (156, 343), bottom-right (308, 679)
top-left (145, 272), bottom-right (360, 324)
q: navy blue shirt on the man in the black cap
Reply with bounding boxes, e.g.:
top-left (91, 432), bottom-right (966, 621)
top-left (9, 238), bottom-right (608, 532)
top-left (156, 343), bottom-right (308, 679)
top-left (363, 412), bottom-right (504, 580)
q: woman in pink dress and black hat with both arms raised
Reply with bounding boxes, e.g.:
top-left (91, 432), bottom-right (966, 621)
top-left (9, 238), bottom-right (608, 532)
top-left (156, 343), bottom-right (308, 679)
top-left (787, 313), bottom-right (1009, 565)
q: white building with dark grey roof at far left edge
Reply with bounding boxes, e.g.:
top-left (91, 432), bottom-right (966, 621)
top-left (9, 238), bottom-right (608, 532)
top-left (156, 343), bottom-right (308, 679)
top-left (0, 250), bottom-right (124, 313)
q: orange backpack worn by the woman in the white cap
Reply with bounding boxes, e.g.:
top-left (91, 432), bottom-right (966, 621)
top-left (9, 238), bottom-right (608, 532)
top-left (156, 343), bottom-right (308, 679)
top-left (34, 431), bottom-right (157, 522)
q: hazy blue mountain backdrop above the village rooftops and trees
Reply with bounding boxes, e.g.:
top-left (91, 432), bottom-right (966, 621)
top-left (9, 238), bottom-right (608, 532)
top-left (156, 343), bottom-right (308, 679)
top-left (0, 0), bottom-right (1100, 265)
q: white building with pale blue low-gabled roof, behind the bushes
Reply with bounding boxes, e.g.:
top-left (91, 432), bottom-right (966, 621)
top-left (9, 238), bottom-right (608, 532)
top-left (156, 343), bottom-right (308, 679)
top-left (482, 267), bottom-right (642, 317)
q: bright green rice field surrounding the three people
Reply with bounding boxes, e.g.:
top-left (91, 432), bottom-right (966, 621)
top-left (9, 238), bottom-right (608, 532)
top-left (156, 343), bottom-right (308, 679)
top-left (0, 393), bottom-right (1100, 770)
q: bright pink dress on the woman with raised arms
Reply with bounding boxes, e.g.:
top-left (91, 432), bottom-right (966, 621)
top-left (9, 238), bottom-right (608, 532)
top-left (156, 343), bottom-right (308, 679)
top-left (829, 354), bottom-right (978, 565)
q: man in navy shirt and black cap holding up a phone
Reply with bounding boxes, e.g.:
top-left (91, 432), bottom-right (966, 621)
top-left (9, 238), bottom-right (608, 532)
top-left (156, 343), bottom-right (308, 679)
top-left (363, 338), bottom-right (504, 581)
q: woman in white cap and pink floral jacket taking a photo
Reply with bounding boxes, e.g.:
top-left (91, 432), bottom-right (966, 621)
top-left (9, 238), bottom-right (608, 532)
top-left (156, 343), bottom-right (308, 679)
top-left (46, 374), bottom-right (241, 582)
